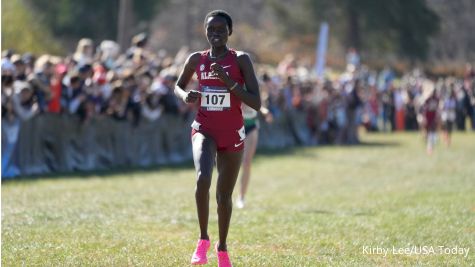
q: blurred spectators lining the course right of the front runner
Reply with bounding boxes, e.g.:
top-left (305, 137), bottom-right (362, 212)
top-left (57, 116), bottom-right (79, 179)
top-left (261, 53), bottom-right (475, 144)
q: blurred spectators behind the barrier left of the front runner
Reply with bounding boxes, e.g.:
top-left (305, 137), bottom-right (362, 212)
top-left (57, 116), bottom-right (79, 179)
top-left (2, 34), bottom-right (197, 124)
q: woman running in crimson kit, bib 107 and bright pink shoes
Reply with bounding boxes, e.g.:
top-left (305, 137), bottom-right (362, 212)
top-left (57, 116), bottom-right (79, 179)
top-left (175, 10), bottom-right (261, 267)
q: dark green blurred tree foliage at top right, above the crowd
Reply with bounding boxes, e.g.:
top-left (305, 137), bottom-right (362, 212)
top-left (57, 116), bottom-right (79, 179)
top-left (304, 0), bottom-right (440, 59)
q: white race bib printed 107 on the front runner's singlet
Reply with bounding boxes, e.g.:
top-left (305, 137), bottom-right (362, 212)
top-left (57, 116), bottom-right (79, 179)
top-left (201, 86), bottom-right (231, 111)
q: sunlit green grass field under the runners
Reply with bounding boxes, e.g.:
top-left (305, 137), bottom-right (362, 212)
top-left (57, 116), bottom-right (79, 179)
top-left (2, 133), bottom-right (475, 266)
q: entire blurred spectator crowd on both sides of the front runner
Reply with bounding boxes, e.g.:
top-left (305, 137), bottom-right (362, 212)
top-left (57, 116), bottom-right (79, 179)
top-left (2, 33), bottom-right (475, 144)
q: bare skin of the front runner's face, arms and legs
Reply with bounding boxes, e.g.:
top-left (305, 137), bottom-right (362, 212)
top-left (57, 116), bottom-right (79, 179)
top-left (175, 16), bottom-right (261, 251)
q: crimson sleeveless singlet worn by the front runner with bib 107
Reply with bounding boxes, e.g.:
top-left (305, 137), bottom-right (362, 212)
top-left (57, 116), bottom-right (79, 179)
top-left (195, 49), bottom-right (244, 130)
